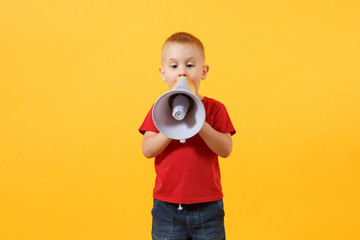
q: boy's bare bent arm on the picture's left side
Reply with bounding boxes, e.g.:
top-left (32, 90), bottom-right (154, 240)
top-left (141, 131), bottom-right (172, 158)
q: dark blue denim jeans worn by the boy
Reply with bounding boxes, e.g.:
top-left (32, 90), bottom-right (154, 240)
top-left (151, 199), bottom-right (225, 240)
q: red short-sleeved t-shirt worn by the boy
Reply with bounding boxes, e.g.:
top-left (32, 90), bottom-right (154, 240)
top-left (139, 97), bottom-right (236, 204)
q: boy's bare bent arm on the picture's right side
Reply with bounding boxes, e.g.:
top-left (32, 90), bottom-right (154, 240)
top-left (199, 122), bottom-right (233, 158)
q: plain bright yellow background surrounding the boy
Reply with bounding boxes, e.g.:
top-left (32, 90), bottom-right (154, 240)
top-left (0, 0), bottom-right (360, 240)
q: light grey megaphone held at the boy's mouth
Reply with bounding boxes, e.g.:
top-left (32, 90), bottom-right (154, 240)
top-left (152, 76), bottom-right (205, 143)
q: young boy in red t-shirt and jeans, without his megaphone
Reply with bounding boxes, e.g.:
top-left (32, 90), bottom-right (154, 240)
top-left (139, 32), bottom-right (236, 240)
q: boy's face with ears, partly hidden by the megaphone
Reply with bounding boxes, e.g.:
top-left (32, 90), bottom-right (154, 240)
top-left (159, 43), bottom-right (209, 93)
